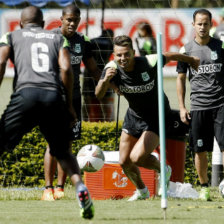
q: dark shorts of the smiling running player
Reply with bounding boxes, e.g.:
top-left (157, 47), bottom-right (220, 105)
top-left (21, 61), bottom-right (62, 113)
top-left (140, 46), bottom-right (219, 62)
top-left (122, 108), bottom-right (170, 138)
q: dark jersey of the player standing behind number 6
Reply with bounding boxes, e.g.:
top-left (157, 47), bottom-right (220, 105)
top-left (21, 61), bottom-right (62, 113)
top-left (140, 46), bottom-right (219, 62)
top-left (52, 28), bottom-right (92, 97)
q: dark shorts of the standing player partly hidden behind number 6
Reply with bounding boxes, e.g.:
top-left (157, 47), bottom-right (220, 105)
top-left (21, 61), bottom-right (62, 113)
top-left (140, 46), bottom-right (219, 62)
top-left (70, 95), bottom-right (82, 140)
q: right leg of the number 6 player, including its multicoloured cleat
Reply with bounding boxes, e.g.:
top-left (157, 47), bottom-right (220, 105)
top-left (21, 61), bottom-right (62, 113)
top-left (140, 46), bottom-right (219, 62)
top-left (39, 91), bottom-right (94, 219)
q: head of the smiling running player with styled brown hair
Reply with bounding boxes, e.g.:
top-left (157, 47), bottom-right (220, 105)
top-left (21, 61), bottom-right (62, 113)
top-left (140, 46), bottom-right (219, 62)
top-left (114, 35), bottom-right (135, 71)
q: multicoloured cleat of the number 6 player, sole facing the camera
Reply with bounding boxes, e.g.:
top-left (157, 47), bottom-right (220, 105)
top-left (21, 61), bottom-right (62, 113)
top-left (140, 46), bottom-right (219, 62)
top-left (76, 184), bottom-right (94, 219)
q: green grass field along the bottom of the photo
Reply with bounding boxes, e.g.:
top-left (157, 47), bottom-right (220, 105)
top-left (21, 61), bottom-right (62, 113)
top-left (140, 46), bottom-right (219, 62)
top-left (0, 187), bottom-right (224, 224)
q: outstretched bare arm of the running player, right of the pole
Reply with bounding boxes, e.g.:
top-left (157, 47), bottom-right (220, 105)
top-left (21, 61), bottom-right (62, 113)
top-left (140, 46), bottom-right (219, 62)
top-left (164, 52), bottom-right (200, 71)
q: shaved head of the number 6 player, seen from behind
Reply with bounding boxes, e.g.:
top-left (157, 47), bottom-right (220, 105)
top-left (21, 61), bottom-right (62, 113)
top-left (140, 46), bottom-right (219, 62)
top-left (20, 6), bottom-right (44, 28)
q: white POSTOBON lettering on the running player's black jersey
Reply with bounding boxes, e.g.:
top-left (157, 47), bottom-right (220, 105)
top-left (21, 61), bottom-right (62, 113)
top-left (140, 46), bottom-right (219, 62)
top-left (119, 80), bottom-right (155, 93)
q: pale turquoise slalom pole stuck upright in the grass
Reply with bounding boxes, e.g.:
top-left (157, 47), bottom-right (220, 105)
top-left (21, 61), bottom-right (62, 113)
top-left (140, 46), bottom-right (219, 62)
top-left (156, 33), bottom-right (167, 219)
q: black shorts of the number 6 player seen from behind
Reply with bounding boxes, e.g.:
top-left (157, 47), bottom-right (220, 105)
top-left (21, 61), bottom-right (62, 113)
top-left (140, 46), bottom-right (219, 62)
top-left (0, 88), bottom-right (72, 158)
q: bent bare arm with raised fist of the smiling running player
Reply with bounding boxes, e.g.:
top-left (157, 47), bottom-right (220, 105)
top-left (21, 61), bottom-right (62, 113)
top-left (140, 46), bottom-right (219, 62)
top-left (95, 68), bottom-right (117, 99)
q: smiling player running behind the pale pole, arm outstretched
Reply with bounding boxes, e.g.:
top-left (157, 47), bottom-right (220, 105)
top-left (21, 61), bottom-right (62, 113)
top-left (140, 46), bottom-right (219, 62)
top-left (95, 35), bottom-right (199, 201)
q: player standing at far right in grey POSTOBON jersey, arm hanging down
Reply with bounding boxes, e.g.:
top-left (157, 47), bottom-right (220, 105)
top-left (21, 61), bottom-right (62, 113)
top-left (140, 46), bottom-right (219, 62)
top-left (177, 9), bottom-right (224, 200)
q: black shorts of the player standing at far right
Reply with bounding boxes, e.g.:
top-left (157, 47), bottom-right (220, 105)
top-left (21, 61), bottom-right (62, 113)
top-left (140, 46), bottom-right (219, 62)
top-left (189, 106), bottom-right (224, 152)
